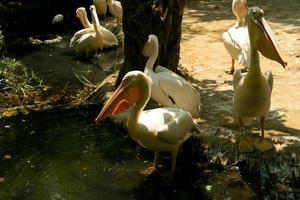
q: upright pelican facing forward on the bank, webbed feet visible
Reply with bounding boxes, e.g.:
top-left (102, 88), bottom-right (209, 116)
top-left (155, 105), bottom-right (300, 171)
top-left (233, 7), bottom-right (287, 152)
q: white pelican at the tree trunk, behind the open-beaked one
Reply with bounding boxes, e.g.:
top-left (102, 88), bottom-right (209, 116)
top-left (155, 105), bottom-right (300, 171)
top-left (143, 35), bottom-right (200, 117)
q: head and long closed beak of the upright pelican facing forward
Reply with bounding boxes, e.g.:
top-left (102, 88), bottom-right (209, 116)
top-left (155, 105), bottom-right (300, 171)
top-left (246, 7), bottom-right (287, 67)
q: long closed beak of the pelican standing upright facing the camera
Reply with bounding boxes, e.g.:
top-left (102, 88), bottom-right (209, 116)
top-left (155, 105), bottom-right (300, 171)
top-left (255, 17), bottom-right (287, 67)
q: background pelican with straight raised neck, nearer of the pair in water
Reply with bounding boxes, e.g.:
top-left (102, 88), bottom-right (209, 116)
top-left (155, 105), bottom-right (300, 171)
top-left (70, 5), bottom-right (118, 53)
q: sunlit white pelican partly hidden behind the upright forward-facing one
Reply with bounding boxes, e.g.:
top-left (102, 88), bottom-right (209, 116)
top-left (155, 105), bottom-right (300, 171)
top-left (222, 0), bottom-right (249, 74)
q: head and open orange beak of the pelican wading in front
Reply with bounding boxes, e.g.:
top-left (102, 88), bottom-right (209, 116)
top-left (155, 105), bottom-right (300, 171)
top-left (95, 71), bottom-right (151, 122)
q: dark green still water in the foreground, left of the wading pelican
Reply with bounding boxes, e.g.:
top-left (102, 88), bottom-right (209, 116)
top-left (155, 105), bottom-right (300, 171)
top-left (0, 106), bottom-right (206, 200)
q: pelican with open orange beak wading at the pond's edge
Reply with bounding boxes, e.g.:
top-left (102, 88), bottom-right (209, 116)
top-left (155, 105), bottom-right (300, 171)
top-left (96, 71), bottom-right (193, 172)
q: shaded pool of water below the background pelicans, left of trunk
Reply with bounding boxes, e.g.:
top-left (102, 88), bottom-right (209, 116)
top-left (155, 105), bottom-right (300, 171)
top-left (7, 31), bottom-right (123, 90)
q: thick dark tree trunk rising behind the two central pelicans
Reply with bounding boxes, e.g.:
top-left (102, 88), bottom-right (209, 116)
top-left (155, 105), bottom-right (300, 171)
top-left (116, 0), bottom-right (185, 85)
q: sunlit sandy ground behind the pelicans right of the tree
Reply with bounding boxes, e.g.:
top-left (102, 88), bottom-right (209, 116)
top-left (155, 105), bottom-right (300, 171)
top-left (180, 0), bottom-right (300, 150)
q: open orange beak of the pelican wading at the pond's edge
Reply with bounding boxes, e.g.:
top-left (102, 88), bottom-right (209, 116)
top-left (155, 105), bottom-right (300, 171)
top-left (95, 81), bottom-right (139, 123)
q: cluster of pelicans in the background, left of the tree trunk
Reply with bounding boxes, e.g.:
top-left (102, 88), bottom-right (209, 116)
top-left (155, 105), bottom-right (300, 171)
top-left (70, 0), bottom-right (122, 55)
